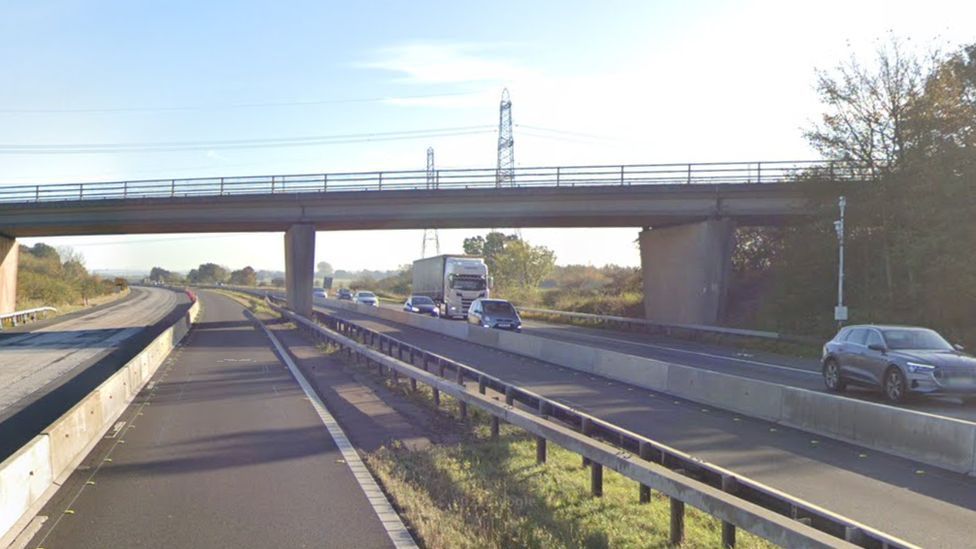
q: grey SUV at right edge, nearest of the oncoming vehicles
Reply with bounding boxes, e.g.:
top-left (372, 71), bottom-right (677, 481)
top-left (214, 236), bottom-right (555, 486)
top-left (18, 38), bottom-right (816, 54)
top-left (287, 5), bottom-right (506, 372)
top-left (823, 325), bottom-right (976, 403)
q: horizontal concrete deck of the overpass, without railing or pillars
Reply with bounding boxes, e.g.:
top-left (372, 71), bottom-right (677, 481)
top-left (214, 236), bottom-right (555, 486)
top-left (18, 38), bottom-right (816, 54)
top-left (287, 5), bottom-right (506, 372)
top-left (0, 183), bottom-right (843, 237)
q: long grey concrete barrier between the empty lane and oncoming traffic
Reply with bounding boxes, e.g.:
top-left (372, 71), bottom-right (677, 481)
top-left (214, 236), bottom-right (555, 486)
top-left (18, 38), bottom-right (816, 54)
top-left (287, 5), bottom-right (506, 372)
top-left (320, 300), bottom-right (976, 475)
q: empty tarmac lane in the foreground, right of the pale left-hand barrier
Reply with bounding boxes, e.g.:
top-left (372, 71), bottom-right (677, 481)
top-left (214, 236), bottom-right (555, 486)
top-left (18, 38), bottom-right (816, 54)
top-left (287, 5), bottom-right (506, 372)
top-left (30, 292), bottom-right (402, 549)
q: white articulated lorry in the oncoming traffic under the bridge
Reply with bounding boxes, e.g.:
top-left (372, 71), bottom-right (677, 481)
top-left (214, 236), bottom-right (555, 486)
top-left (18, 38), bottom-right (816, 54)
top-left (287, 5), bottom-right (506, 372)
top-left (413, 255), bottom-right (491, 318)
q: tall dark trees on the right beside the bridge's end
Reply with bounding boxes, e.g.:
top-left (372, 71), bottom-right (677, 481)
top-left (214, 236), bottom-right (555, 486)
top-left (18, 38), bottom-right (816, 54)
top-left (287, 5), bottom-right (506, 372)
top-left (732, 39), bottom-right (976, 345)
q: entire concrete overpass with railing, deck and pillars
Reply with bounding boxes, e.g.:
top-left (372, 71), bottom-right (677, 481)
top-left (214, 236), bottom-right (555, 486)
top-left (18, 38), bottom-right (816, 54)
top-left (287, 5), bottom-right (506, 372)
top-left (0, 161), bottom-right (871, 324)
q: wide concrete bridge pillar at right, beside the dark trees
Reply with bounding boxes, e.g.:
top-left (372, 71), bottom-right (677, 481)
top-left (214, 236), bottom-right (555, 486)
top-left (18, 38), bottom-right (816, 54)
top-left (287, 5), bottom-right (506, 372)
top-left (639, 219), bottom-right (735, 324)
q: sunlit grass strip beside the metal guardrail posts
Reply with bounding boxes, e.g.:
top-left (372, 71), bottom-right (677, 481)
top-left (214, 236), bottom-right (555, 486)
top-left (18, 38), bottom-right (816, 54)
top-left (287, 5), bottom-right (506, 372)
top-left (312, 345), bottom-right (774, 548)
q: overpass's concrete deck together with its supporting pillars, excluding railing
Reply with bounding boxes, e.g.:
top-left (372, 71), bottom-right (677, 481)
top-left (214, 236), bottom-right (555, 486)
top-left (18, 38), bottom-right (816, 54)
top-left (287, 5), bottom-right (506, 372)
top-left (0, 182), bottom-right (850, 324)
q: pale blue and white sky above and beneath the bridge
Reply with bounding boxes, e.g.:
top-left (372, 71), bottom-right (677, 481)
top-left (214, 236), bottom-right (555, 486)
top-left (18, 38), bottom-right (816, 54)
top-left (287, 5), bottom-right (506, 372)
top-left (0, 0), bottom-right (976, 271)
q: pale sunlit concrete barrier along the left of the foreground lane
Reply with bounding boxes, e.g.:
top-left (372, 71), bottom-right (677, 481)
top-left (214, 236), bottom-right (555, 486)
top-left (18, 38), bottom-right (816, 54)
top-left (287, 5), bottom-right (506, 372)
top-left (0, 296), bottom-right (200, 547)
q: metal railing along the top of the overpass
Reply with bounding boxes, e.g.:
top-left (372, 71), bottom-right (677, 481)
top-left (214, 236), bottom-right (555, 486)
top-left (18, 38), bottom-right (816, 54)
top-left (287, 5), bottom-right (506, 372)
top-left (0, 160), bottom-right (873, 203)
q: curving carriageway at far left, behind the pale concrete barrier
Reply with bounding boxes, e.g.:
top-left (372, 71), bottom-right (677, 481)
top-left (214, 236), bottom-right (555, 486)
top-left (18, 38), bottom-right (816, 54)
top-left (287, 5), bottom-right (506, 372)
top-left (0, 287), bottom-right (189, 459)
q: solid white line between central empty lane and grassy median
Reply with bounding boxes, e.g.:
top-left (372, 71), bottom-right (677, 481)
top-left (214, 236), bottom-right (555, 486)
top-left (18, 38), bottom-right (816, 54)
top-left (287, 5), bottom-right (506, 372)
top-left (249, 315), bottom-right (417, 549)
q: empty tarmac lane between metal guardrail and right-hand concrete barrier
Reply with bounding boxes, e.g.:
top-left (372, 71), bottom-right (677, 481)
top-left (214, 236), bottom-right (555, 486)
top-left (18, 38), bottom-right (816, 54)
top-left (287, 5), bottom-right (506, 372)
top-left (317, 307), bottom-right (976, 547)
